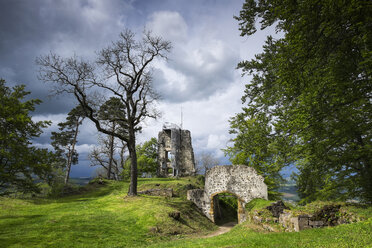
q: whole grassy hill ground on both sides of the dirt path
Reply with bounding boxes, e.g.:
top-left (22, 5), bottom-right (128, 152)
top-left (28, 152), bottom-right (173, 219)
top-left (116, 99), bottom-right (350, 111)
top-left (0, 178), bottom-right (372, 247)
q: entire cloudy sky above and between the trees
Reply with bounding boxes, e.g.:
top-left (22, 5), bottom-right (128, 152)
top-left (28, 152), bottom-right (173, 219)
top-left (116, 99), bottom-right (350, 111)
top-left (0, 0), bottom-right (275, 177)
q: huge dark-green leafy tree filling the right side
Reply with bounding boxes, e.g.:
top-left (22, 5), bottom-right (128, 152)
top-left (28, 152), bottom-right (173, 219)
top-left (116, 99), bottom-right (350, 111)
top-left (232, 0), bottom-right (372, 202)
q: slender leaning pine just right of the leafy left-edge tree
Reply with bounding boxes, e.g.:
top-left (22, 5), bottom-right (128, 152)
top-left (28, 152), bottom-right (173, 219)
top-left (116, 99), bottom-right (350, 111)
top-left (51, 105), bottom-right (85, 185)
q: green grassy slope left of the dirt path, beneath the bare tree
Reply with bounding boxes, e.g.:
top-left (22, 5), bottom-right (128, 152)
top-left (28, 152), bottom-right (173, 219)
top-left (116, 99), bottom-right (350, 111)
top-left (0, 179), bottom-right (216, 247)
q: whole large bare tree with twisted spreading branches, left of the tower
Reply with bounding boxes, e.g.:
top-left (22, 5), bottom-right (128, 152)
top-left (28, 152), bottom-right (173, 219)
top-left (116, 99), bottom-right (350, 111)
top-left (36, 30), bottom-right (171, 195)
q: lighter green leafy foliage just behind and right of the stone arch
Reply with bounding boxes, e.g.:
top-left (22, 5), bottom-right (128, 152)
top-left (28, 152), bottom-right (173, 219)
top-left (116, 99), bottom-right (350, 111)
top-left (225, 108), bottom-right (289, 200)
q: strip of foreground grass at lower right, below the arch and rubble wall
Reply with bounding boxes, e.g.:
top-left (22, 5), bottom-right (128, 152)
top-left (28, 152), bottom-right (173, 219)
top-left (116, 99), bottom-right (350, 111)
top-left (145, 219), bottom-right (372, 248)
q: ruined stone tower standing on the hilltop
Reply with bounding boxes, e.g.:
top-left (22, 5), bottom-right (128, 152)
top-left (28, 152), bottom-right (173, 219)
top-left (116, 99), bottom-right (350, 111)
top-left (158, 123), bottom-right (195, 177)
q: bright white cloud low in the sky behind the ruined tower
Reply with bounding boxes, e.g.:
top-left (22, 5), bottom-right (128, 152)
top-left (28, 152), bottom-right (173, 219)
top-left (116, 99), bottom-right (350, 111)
top-left (138, 72), bottom-right (244, 163)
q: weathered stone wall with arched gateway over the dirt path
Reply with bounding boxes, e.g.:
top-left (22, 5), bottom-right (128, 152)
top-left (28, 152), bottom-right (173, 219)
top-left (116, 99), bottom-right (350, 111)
top-left (187, 165), bottom-right (267, 223)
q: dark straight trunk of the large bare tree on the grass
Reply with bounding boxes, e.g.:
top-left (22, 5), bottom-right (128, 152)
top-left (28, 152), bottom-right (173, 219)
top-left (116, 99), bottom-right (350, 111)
top-left (128, 128), bottom-right (138, 196)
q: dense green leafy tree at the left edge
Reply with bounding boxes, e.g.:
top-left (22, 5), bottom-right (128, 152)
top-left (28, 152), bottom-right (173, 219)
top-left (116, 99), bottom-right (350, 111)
top-left (0, 79), bottom-right (55, 195)
